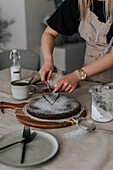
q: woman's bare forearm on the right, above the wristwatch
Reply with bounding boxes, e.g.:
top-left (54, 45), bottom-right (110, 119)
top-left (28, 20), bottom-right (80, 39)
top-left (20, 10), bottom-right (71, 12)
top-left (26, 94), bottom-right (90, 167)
top-left (82, 47), bottom-right (113, 77)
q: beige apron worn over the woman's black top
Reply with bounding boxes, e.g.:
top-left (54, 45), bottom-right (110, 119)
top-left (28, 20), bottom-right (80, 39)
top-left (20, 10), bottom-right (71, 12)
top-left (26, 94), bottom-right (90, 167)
top-left (79, 8), bottom-right (113, 83)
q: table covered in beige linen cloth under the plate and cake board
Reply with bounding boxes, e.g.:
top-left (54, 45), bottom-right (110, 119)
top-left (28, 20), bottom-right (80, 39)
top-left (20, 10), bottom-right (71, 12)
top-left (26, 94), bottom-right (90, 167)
top-left (0, 69), bottom-right (113, 170)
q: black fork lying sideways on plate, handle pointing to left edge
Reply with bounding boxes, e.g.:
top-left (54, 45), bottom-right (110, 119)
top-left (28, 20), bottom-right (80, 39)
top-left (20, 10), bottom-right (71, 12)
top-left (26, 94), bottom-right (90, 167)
top-left (0, 132), bottom-right (37, 151)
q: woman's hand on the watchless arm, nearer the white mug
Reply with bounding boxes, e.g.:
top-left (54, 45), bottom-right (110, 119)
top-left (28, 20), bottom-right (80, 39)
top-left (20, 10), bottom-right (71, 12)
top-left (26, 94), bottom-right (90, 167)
top-left (39, 60), bottom-right (53, 82)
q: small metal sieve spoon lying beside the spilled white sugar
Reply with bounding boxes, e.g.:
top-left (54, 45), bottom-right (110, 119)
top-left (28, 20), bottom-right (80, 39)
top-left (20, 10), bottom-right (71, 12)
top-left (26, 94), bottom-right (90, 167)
top-left (72, 117), bottom-right (113, 134)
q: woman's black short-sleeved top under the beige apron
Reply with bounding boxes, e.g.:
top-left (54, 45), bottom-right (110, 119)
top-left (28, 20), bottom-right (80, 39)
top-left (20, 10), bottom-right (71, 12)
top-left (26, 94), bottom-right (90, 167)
top-left (47, 0), bottom-right (113, 43)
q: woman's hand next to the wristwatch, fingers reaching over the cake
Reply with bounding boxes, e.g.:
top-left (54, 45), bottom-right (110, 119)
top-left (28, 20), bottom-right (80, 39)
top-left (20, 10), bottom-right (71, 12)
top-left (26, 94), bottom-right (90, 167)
top-left (52, 70), bottom-right (80, 93)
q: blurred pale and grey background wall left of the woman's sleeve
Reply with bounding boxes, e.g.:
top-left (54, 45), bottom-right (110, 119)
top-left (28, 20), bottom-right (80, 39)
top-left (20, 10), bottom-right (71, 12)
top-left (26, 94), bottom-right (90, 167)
top-left (0, 0), bottom-right (55, 53)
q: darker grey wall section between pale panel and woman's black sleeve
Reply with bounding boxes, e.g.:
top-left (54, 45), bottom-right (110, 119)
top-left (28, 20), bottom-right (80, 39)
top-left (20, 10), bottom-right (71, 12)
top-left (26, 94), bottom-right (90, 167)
top-left (25, 0), bottom-right (55, 53)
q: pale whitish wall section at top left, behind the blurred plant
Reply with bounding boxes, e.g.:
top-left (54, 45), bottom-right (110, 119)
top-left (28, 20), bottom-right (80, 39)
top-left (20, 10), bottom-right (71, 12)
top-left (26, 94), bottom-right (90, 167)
top-left (0, 0), bottom-right (27, 49)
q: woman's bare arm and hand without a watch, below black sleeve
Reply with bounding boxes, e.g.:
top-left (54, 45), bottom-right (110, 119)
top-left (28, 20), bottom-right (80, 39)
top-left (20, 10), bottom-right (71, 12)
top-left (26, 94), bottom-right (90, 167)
top-left (39, 26), bottom-right (58, 82)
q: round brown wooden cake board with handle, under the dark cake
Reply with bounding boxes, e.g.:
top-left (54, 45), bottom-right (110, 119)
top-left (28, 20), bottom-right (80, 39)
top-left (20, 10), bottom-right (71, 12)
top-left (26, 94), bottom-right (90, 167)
top-left (0, 102), bottom-right (86, 129)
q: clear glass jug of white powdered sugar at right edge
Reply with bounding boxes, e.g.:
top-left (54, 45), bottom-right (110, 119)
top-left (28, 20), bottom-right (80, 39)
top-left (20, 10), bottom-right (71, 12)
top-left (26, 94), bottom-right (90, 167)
top-left (89, 83), bottom-right (113, 122)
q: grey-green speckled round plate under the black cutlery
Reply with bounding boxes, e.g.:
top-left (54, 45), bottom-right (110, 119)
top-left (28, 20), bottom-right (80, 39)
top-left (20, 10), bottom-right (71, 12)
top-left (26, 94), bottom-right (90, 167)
top-left (0, 130), bottom-right (59, 167)
